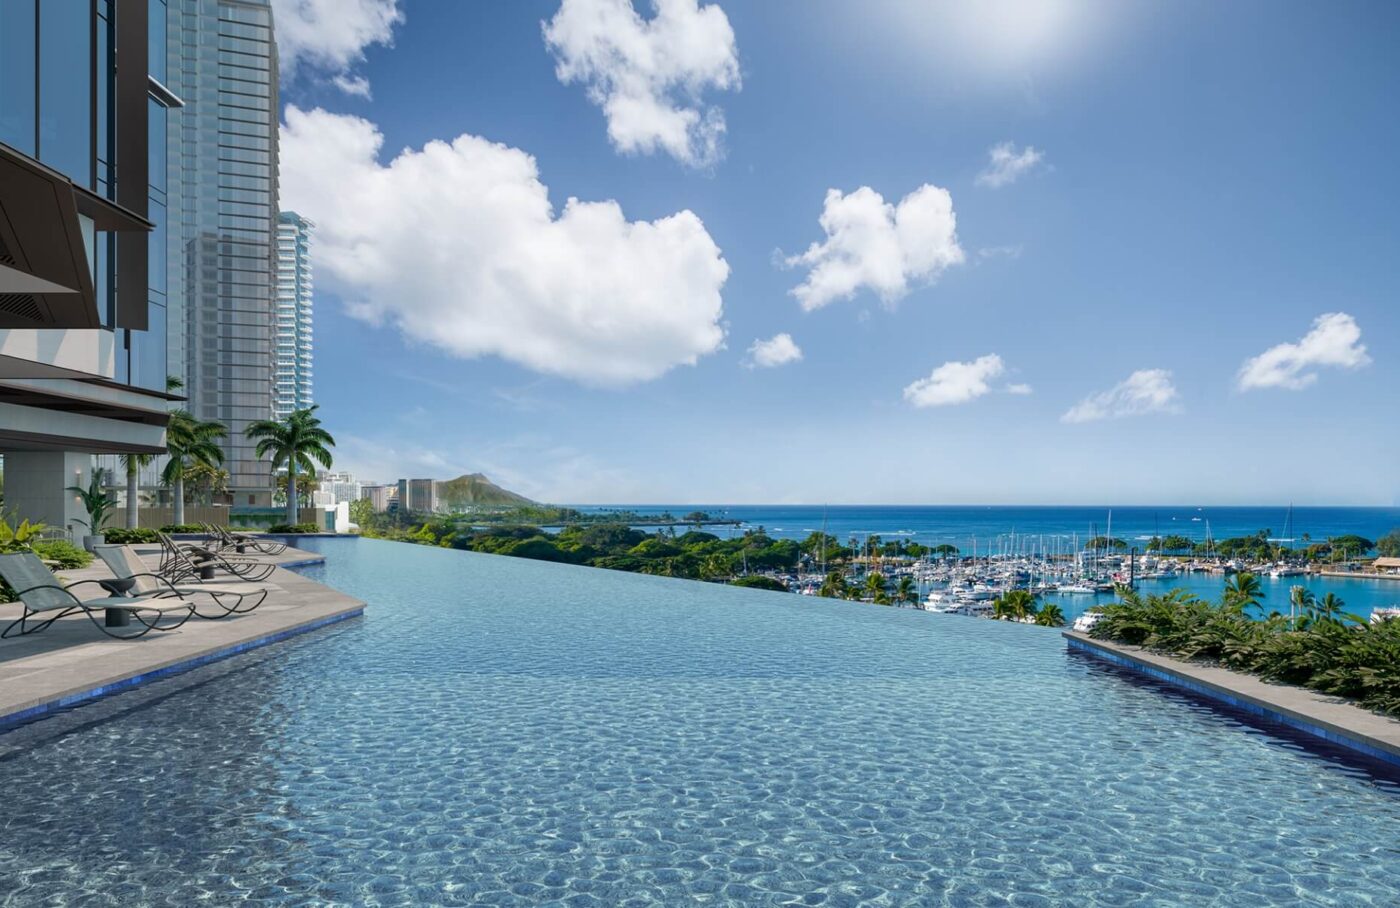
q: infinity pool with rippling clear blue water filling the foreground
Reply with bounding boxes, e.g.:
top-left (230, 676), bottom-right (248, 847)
top-left (0, 540), bottom-right (1400, 907)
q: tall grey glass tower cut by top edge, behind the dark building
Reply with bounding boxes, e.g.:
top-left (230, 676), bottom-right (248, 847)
top-left (167, 0), bottom-right (277, 502)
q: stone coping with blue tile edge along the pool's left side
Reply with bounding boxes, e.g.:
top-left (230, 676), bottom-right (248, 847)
top-left (0, 548), bottom-right (365, 735)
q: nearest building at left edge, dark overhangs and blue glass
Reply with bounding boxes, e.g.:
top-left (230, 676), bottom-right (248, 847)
top-left (0, 0), bottom-right (182, 536)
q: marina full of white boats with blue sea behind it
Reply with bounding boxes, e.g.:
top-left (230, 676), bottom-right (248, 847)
top-left (715, 508), bottom-right (1400, 621)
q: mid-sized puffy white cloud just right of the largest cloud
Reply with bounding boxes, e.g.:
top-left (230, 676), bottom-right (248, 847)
top-left (785, 183), bottom-right (966, 312)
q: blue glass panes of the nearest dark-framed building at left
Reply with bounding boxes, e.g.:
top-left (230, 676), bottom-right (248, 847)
top-left (0, 0), bottom-right (171, 390)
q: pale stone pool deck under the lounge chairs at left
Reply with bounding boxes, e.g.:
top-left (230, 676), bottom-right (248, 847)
top-left (0, 546), bottom-right (365, 730)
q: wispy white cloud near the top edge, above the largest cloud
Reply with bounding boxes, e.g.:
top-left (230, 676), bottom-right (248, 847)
top-left (543, 0), bottom-right (739, 166)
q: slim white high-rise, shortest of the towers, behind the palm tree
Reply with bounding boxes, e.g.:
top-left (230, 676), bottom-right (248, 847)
top-left (272, 211), bottom-right (313, 416)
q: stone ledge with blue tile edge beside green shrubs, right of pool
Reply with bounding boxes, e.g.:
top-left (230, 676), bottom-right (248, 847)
top-left (1064, 631), bottom-right (1400, 767)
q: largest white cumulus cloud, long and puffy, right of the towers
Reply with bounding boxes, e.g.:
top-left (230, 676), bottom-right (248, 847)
top-left (281, 106), bottom-right (729, 386)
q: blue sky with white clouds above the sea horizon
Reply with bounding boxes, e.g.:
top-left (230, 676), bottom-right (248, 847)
top-left (274, 0), bottom-right (1400, 505)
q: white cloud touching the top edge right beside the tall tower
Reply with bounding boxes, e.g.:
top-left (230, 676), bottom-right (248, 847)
top-left (272, 0), bottom-right (403, 98)
